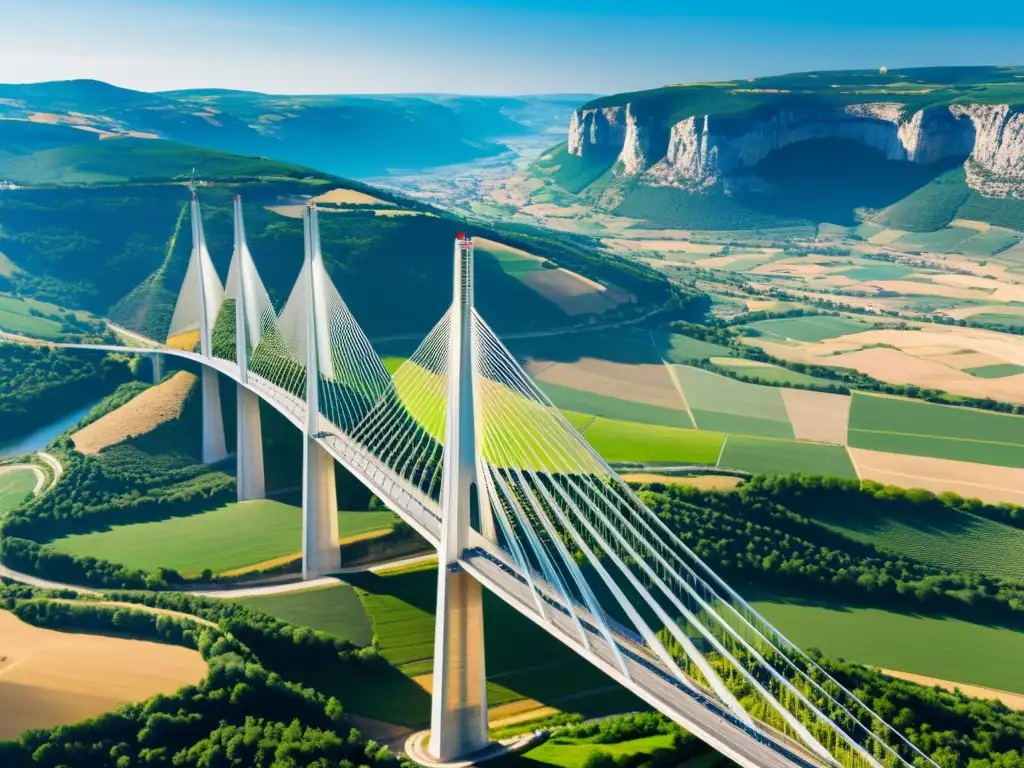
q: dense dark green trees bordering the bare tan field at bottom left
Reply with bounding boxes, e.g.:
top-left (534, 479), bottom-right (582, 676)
top-left (0, 584), bottom-right (403, 768)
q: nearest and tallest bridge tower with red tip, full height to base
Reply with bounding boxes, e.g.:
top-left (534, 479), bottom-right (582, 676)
top-left (429, 233), bottom-right (488, 761)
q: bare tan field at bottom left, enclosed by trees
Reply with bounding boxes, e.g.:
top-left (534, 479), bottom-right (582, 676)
top-left (0, 610), bottom-right (207, 740)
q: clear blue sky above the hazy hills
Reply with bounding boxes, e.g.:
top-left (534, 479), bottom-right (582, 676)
top-left (0, 0), bottom-right (1024, 94)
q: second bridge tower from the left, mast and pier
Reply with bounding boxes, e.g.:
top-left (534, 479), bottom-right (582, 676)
top-left (234, 195), bottom-right (266, 502)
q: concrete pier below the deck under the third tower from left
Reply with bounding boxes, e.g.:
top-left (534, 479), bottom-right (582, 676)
top-left (302, 435), bottom-right (341, 579)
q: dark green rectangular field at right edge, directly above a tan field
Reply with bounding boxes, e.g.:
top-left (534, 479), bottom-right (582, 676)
top-left (849, 392), bottom-right (1024, 467)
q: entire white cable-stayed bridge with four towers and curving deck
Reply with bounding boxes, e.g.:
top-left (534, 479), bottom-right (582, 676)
top-left (28, 193), bottom-right (934, 768)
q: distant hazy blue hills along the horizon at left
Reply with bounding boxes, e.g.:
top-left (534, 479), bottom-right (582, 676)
top-left (0, 80), bottom-right (593, 178)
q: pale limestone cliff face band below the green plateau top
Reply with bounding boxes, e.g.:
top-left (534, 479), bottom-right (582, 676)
top-left (568, 102), bottom-right (1024, 198)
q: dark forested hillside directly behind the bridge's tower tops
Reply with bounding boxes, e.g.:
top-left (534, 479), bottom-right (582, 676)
top-left (0, 139), bottom-right (685, 338)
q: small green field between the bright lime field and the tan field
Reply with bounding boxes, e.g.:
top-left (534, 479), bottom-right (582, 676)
top-left (718, 434), bottom-right (857, 478)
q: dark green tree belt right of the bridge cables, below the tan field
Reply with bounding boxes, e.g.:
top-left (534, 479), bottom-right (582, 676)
top-left (641, 476), bottom-right (1024, 626)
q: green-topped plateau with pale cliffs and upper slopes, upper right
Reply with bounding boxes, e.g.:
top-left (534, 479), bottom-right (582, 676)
top-left (536, 67), bottom-right (1024, 230)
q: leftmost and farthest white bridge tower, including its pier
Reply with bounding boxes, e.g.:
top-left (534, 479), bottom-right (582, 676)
top-left (190, 189), bottom-right (227, 464)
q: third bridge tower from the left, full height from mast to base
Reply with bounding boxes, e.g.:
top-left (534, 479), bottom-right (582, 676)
top-left (302, 206), bottom-right (341, 579)
